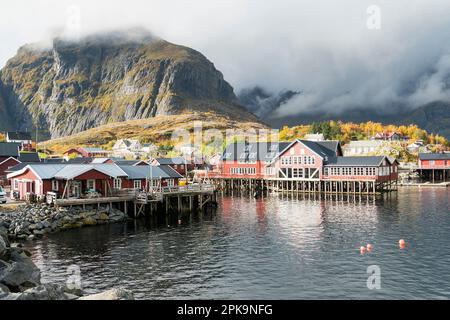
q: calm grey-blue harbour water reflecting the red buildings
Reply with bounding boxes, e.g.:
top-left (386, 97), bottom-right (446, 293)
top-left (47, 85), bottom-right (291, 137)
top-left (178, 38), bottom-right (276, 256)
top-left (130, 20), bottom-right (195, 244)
top-left (27, 189), bottom-right (450, 299)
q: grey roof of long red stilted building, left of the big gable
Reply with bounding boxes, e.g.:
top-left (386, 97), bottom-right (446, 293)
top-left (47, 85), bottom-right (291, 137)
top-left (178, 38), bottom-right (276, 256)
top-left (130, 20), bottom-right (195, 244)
top-left (222, 142), bottom-right (291, 162)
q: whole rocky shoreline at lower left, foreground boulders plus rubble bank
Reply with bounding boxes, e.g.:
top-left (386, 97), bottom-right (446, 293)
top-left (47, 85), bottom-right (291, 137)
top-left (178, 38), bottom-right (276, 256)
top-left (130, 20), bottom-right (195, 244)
top-left (0, 205), bottom-right (134, 300)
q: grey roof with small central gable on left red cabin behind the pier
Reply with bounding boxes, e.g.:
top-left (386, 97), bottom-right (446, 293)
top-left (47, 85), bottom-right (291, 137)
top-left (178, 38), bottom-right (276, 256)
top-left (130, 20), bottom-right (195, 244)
top-left (55, 164), bottom-right (127, 180)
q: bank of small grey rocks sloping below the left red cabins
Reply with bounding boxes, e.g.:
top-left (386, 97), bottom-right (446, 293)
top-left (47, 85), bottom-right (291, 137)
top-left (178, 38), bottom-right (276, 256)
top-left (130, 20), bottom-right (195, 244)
top-left (0, 204), bottom-right (128, 240)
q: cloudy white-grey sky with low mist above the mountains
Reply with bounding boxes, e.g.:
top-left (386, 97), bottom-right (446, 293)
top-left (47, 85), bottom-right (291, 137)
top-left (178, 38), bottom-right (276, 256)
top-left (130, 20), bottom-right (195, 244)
top-left (0, 0), bottom-right (450, 116)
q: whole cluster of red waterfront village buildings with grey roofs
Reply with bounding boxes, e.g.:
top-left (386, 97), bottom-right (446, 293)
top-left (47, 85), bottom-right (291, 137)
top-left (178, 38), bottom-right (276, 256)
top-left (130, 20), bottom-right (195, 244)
top-left (0, 129), bottom-right (450, 199)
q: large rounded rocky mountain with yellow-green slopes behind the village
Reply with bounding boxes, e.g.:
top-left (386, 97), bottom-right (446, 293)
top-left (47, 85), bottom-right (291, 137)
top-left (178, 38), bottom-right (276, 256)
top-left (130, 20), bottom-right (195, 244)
top-left (0, 30), bottom-right (257, 138)
